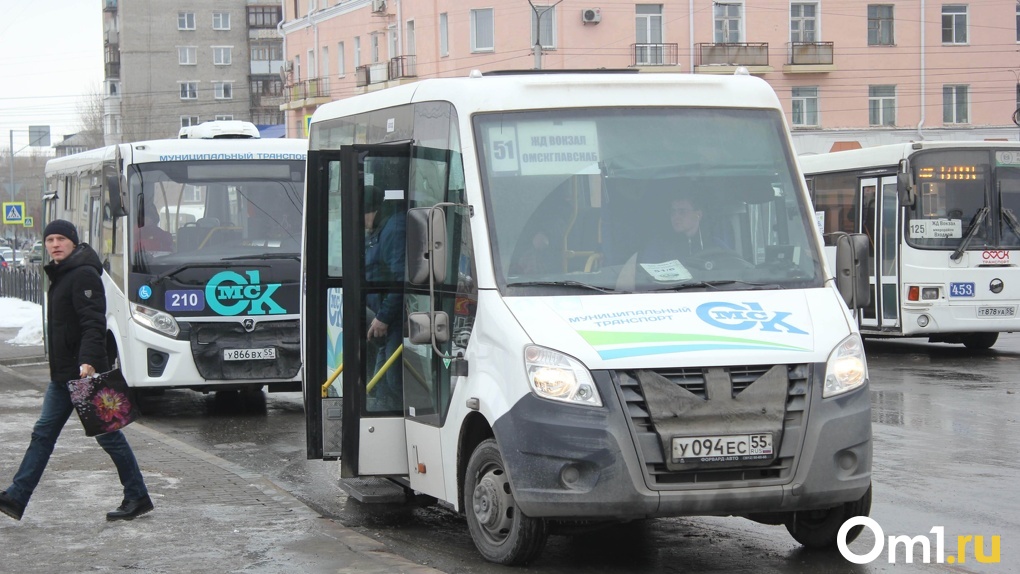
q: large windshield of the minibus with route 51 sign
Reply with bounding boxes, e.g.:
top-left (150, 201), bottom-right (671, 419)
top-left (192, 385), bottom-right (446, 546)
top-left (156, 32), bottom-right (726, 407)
top-left (474, 108), bottom-right (823, 294)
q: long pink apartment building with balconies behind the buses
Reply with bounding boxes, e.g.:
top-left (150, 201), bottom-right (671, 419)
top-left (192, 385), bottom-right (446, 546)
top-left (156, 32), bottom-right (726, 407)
top-left (281, 0), bottom-right (1020, 153)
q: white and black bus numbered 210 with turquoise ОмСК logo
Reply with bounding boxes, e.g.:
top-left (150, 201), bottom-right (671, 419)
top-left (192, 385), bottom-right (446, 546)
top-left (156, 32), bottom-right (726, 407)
top-left (45, 122), bottom-right (308, 390)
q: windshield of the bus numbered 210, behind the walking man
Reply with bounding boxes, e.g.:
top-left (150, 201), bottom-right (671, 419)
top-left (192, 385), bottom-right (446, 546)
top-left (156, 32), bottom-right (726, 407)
top-left (128, 160), bottom-right (304, 274)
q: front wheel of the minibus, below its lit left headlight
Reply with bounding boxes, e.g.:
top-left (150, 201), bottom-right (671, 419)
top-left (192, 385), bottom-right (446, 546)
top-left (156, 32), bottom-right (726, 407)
top-left (464, 438), bottom-right (549, 565)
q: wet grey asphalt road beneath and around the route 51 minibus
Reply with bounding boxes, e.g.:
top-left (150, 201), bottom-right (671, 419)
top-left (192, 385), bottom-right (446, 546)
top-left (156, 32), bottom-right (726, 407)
top-left (37, 334), bottom-right (1020, 574)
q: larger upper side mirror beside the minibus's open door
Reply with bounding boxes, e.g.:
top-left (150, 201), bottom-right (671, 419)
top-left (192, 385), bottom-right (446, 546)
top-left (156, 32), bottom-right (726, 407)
top-left (407, 207), bottom-right (447, 285)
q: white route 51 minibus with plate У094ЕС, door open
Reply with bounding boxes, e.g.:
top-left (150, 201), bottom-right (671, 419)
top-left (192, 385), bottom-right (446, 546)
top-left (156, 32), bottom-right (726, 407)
top-left (302, 72), bottom-right (871, 564)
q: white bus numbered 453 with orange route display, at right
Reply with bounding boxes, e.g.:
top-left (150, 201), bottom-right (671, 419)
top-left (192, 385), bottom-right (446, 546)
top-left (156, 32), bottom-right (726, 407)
top-left (800, 142), bottom-right (1020, 349)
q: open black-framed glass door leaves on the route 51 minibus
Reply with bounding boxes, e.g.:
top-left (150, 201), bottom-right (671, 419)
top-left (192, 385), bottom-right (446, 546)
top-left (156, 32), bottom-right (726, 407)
top-left (303, 145), bottom-right (410, 478)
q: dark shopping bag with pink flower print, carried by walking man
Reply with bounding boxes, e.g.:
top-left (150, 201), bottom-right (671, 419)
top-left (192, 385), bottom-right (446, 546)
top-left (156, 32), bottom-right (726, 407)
top-left (67, 369), bottom-right (142, 436)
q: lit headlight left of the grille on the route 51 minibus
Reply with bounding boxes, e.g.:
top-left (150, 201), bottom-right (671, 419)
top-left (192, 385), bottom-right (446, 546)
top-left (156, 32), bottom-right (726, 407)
top-left (524, 345), bottom-right (602, 407)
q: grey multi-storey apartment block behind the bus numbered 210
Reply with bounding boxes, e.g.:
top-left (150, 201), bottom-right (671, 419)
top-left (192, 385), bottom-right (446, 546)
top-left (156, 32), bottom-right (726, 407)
top-left (103, 0), bottom-right (286, 145)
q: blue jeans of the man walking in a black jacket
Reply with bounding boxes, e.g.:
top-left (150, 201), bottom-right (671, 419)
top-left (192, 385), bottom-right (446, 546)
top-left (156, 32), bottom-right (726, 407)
top-left (7, 382), bottom-right (149, 505)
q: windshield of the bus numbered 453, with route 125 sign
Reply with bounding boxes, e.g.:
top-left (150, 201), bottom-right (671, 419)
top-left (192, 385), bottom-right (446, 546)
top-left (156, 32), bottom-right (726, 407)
top-left (906, 150), bottom-right (1020, 250)
